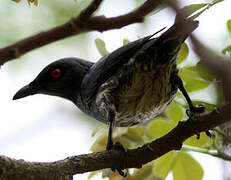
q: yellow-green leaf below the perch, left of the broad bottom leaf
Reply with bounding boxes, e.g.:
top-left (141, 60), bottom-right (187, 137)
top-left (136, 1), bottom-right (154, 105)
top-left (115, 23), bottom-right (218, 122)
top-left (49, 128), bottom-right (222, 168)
top-left (154, 151), bottom-right (175, 179)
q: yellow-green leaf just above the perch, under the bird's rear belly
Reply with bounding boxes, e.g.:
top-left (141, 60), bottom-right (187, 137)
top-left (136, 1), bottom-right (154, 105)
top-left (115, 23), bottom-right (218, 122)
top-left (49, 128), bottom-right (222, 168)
top-left (148, 118), bottom-right (175, 139)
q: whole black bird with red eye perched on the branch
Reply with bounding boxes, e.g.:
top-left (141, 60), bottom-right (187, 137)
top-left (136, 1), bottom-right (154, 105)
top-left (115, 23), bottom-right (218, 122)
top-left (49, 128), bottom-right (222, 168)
top-left (13, 20), bottom-right (203, 175)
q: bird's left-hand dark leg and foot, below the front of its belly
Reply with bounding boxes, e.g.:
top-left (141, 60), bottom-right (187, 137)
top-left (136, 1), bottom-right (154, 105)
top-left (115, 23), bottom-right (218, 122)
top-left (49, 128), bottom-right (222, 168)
top-left (106, 110), bottom-right (127, 177)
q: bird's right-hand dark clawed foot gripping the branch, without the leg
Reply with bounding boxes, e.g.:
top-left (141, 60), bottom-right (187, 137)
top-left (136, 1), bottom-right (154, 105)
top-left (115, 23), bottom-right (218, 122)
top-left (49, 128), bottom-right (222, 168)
top-left (186, 104), bottom-right (212, 140)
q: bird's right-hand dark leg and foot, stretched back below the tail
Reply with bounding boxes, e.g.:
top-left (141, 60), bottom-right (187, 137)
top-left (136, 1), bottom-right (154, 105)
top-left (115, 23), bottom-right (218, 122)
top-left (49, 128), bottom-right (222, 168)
top-left (174, 74), bottom-right (211, 139)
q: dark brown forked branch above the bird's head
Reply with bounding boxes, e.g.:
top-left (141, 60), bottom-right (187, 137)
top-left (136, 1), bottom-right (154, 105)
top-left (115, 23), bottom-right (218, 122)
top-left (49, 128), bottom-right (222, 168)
top-left (0, 0), bottom-right (162, 65)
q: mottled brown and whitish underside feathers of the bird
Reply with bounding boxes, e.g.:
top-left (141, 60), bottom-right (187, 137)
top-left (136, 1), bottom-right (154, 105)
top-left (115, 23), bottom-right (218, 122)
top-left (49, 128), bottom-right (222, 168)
top-left (93, 53), bottom-right (177, 126)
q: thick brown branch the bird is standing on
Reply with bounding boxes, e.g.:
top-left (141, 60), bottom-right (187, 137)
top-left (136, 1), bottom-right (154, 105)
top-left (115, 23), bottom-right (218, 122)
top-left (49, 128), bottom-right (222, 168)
top-left (0, 105), bottom-right (231, 180)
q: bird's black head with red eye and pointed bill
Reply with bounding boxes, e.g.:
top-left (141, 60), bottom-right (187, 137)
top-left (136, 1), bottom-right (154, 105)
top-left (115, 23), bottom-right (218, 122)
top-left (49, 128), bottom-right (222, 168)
top-left (13, 58), bottom-right (92, 103)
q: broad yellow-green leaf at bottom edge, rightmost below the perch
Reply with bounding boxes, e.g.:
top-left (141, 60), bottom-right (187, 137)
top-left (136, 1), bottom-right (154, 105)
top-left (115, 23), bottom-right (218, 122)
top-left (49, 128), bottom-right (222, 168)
top-left (173, 152), bottom-right (204, 180)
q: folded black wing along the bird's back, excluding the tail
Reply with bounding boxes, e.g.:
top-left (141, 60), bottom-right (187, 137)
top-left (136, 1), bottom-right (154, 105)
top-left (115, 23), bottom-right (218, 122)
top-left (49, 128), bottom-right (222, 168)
top-left (81, 35), bottom-right (153, 103)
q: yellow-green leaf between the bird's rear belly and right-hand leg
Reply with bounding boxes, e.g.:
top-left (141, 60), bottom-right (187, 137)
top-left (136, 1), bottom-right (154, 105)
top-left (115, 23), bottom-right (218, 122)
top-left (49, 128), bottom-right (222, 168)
top-left (165, 101), bottom-right (184, 124)
